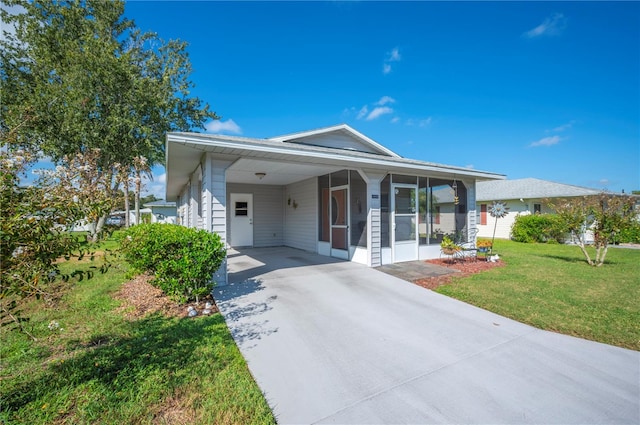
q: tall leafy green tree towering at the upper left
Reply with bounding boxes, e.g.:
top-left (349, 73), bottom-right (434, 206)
top-left (0, 0), bottom-right (218, 238)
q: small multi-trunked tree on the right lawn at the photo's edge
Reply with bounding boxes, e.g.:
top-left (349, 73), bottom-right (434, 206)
top-left (545, 193), bottom-right (637, 267)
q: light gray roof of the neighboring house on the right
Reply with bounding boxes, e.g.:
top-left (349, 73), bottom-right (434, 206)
top-left (476, 178), bottom-right (602, 201)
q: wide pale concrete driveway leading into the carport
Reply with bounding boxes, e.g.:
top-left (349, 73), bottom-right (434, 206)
top-left (215, 248), bottom-right (640, 424)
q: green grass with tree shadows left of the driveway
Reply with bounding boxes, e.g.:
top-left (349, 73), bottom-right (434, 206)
top-left (0, 253), bottom-right (275, 424)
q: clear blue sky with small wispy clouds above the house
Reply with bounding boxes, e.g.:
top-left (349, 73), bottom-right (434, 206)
top-left (125, 1), bottom-right (640, 197)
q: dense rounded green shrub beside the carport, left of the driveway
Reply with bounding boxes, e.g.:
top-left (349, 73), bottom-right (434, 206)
top-left (121, 223), bottom-right (226, 303)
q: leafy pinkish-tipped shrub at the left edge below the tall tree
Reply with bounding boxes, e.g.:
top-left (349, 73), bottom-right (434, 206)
top-left (0, 149), bottom-right (108, 332)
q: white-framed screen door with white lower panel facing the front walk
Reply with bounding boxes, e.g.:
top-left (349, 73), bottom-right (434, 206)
top-left (391, 184), bottom-right (418, 263)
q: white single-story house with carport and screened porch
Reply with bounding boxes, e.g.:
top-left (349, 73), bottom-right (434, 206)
top-left (166, 124), bottom-right (504, 284)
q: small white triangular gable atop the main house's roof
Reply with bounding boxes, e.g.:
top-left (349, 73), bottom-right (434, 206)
top-left (268, 124), bottom-right (401, 158)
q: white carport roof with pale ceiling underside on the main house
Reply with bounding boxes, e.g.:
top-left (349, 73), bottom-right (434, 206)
top-left (166, 125), bottom-right (505, 200)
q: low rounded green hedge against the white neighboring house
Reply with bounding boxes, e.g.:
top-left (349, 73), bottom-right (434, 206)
top-left (511, 214), bottom-right (566, 243)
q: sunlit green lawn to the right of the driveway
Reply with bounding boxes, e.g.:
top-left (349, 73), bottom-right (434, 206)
top-left (437, 240), bottom-right (640, 350)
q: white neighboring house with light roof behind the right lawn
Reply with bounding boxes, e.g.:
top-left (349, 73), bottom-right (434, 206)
top-left (476, 178), bottom-right (602, 239)
